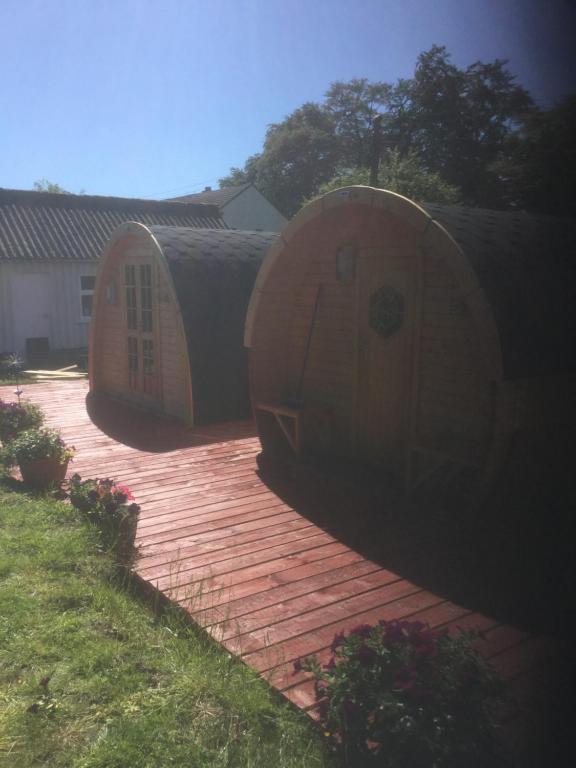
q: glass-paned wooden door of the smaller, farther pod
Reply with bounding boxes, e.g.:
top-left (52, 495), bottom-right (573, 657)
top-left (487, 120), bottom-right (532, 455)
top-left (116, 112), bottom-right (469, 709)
top-left (124, 262), bottom-right (161, 407)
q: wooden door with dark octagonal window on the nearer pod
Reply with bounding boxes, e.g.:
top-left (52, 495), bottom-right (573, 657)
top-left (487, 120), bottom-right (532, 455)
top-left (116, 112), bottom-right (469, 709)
top-left (354, 249), bottom-right (414, 476)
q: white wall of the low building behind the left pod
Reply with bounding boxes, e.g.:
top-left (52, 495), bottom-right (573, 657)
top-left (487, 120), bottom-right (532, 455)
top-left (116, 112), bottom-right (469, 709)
top-left (0, 261), bottom-right (97, 353)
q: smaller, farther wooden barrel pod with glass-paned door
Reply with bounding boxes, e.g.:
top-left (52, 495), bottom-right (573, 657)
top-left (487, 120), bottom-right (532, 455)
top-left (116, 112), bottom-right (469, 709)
top-left (89, 222), bottom-right (277, 425)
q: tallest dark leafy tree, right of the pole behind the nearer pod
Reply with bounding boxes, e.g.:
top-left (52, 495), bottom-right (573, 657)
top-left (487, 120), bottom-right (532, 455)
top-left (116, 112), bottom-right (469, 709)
top-left (385, 46), bottom-right (533, 207)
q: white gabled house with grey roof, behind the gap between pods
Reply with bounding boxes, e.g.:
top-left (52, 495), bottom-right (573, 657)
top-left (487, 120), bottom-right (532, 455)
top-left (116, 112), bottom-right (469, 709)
top-left (174, 184), bottom-right (288, 232)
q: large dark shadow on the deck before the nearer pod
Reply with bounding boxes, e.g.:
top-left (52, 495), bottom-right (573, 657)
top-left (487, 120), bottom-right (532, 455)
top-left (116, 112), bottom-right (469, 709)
top-left (258, 441), bottom-right (576, 636)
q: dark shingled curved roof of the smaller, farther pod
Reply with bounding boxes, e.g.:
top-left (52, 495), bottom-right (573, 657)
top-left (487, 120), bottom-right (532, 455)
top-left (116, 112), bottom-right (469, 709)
top-left (149, 226), bottom-right (278, 423)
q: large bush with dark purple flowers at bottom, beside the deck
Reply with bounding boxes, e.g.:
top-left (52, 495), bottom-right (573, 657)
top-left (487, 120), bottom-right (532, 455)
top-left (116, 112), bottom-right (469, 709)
top-left (295, 621), bottom-right (503, 768)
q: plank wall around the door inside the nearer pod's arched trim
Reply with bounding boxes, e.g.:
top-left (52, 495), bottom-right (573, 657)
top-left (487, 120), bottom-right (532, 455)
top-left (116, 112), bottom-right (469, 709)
top-left (251, 207), bottom-right (494, 463)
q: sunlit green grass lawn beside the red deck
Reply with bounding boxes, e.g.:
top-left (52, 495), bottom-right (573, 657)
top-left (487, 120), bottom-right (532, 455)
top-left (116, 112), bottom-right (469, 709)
top-left (0, 483), bottom-right (335, 768)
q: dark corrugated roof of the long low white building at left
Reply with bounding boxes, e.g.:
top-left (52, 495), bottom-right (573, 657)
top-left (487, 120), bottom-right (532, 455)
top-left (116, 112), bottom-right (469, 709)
top-left (0, 189), bottom-right (226, 261)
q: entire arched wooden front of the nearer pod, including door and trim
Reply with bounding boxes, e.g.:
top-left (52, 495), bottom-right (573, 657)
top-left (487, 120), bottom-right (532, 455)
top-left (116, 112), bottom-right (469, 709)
top-left (245, 187), bottom-right (502, 476)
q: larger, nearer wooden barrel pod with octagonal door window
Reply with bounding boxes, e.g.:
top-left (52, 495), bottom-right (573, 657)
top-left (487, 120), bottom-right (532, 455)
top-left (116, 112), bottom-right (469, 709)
top-left (245, 187), bottom-right (576, 484)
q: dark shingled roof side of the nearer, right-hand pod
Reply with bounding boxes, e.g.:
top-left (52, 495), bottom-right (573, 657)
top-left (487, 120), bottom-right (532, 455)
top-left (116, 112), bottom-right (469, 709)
top-left (422, 204), bottom-right (576, 378)
